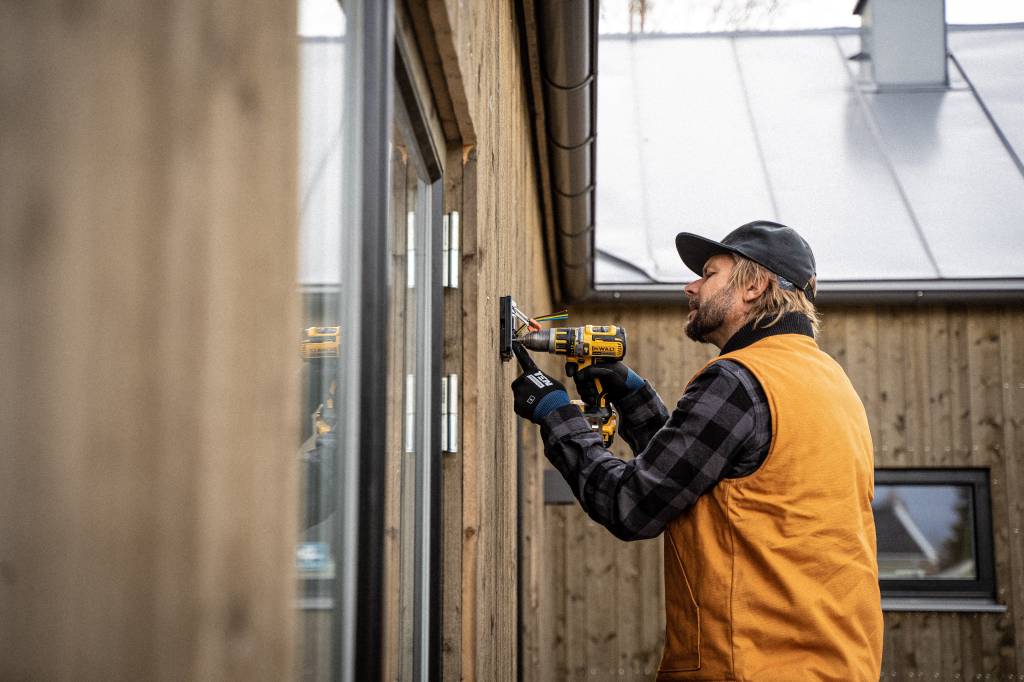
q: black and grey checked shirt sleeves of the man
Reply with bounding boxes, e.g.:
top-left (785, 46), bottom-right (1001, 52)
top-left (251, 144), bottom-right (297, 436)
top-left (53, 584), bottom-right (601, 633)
top-left (541, 360), bottom-right (771, 540)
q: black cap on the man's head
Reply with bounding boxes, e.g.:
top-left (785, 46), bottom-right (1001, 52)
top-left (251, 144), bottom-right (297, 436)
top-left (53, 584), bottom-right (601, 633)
top-left (676, 220), bottom-right (815, 300)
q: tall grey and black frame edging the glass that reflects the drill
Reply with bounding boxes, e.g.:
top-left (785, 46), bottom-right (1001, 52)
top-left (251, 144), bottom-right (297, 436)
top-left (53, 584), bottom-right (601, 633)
top-left (331, 0), bottom-right (394, 682)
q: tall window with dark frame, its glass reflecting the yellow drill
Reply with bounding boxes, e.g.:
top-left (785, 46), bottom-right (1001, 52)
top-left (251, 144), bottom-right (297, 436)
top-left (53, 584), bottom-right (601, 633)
top-left (296, 0), bottom-right (399, 680)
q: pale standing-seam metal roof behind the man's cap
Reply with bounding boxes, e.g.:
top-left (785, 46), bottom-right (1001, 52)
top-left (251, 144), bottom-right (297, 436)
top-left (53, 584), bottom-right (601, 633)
top-left (595, 25), bottom-right (1024, 297)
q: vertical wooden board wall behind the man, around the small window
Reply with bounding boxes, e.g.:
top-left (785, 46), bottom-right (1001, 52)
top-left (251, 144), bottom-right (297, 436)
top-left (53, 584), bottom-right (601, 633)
top-left (526, 306), bottom-right (1024, 680)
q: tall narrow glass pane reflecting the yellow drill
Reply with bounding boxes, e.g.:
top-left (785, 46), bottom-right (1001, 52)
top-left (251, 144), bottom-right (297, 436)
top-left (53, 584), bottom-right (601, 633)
top-left (295, 0), bottom-right (345, 680)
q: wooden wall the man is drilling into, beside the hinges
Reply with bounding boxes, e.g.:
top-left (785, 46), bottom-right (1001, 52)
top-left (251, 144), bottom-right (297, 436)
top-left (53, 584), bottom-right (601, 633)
top-left (425, 0), bottom-right (558, 680)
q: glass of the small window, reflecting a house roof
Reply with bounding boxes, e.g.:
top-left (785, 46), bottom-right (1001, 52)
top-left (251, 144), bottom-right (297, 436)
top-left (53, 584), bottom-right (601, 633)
top-left (871, 484), bottom-right (978, 581)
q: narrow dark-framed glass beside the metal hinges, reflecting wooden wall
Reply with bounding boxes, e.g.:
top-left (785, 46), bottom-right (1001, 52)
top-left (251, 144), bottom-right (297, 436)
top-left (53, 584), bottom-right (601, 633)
top-left (383, 70), bottom-right (443, 680)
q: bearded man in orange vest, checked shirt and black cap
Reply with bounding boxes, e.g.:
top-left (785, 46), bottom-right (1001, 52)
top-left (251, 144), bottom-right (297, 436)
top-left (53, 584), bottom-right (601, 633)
top-left (512, 220), bottom-right (882, 682)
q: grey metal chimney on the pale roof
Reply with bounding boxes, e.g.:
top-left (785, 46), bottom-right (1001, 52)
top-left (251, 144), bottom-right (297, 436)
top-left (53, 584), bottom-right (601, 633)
top-left (853, 0), bottom-right (949, 91)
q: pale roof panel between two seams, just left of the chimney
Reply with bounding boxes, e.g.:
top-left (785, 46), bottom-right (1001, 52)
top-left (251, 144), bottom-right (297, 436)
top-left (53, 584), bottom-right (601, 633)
top-left (738, 36), bottom-right (937, 280)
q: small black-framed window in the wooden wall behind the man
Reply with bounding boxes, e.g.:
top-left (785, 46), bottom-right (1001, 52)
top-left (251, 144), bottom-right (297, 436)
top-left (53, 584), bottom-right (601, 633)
top-left (871, 469), bottom-right (995, 600)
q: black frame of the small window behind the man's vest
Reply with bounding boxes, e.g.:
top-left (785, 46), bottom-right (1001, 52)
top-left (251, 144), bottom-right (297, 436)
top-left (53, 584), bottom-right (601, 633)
top-left (874, 468), bottom-right (995, 602)
